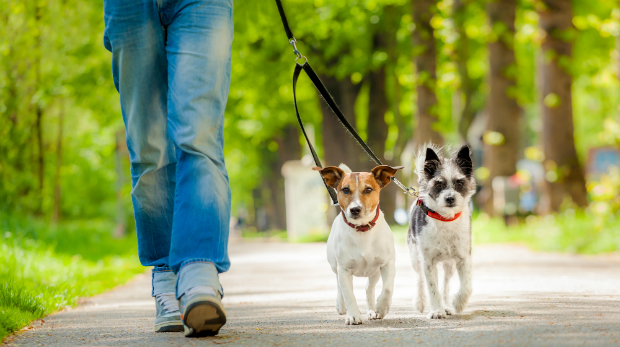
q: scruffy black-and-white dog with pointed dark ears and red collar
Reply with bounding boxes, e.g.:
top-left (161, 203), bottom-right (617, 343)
top-left (407, 145), bottom-right (476, 319)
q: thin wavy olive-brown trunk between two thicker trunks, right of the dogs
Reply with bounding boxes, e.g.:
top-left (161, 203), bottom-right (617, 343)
top-left (453, 0), bottom-right (478, 142)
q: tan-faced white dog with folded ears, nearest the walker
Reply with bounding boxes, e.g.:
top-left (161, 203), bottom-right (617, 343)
top-left (314, 164), bottom-right (403, 325)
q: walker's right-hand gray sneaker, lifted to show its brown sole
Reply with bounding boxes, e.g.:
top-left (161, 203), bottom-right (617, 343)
top-left (181, 286), bottom-right (226, 337)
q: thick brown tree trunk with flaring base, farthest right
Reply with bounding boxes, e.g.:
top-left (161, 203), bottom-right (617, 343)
top-left (539, 0), bottom-right (587, 212)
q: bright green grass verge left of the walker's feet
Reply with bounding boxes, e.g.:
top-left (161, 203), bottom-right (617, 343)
top-left (0, 213), bottom-right (144, 341)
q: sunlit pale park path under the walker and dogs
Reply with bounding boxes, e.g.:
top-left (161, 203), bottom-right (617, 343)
top-left (5, 243), bottom-right (620, 347)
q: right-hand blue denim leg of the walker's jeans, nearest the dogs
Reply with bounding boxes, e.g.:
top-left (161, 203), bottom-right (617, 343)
top-left (166, 0), bottom-right (233, 282)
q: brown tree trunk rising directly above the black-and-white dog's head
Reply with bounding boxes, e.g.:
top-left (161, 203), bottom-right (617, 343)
top-left (412, 0), bottom-right (443, 147)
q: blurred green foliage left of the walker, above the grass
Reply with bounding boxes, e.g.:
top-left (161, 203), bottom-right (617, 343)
top-left (0, 0), bottom-right (122, 218)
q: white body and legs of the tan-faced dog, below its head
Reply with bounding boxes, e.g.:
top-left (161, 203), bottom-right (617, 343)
top-left (327, 211), bottom-right (395, 324)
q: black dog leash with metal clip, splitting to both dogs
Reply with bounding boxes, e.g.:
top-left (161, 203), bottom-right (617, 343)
top-left (276, 0), bottom-right (418, 206)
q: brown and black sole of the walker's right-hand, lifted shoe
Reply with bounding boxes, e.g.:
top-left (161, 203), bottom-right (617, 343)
top-left (181, 298), bottom-right (226, 337)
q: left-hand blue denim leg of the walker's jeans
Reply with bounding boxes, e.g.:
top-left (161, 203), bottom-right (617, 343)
top-left (104, 0), bottom-right (176, 271)
